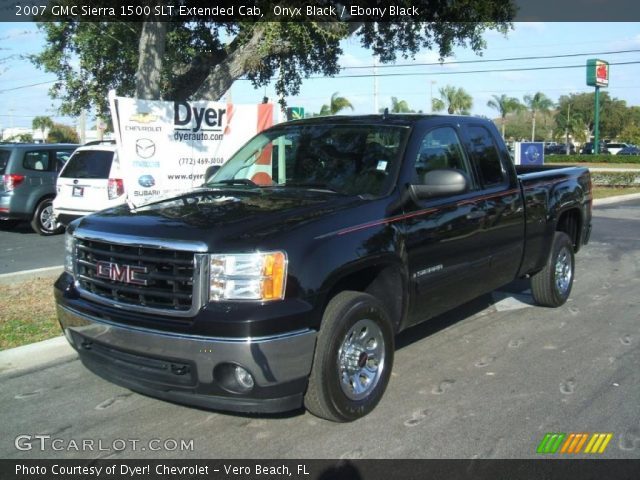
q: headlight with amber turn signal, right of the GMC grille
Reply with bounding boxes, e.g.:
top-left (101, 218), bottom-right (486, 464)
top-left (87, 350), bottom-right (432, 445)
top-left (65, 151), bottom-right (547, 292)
top-left (209, 252), bottom-right (287, 302)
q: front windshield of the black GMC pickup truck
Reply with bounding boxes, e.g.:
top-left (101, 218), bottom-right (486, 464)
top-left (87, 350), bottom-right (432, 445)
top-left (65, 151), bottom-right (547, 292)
top-left (206, 124), bottom-right (409, 196)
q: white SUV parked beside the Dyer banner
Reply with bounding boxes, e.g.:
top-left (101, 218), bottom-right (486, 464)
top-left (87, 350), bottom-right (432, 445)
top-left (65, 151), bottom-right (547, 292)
top-left (53, 141), bottom-right (125, 226)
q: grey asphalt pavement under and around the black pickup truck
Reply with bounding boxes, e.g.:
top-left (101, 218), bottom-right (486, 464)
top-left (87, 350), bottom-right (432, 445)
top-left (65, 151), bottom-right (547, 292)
top-left (0, 200), bottom-right (640, 459)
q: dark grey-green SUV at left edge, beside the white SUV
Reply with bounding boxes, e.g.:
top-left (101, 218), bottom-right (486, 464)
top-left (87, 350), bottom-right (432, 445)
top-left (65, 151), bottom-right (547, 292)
top-left (0, 143), bottom-right (78, 235)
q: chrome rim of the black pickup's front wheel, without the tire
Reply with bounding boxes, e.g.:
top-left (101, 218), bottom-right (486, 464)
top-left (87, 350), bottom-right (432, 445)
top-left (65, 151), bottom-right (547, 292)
top-left (338, 319), bottom-right (385, 400)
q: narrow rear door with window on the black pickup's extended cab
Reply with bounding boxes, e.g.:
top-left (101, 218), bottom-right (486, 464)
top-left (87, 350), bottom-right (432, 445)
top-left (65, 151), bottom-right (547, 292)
top-left (462, 121), bottom-right (525, 293)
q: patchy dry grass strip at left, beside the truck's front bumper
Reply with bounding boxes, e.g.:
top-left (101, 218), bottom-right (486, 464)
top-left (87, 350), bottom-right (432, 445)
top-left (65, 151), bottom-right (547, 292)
top-left (0, 278), bottom-right (62, 350)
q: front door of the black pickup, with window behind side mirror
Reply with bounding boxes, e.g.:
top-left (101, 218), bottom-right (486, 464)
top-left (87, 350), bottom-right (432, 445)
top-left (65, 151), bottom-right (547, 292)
top-left (404, 123), bottom-right (490, 324)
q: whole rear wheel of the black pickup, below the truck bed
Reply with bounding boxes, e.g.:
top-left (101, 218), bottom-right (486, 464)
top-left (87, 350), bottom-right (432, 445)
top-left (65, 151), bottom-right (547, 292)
top-left (531, 232), bottom-right (575, 307)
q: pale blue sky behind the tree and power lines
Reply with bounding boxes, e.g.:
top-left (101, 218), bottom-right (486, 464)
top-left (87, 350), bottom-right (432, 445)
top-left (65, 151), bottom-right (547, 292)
top-left (0, 22), bottom-right (640, 131)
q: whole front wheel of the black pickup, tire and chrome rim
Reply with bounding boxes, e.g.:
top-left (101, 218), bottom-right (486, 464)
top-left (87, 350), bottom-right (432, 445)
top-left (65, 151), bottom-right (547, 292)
top-left (304, 291), bottom-right (395, 422)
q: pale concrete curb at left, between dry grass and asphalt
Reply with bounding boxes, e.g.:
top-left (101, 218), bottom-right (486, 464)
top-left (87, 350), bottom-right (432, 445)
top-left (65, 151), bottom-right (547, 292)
top-left (0, 336), bottom-right (76, 377)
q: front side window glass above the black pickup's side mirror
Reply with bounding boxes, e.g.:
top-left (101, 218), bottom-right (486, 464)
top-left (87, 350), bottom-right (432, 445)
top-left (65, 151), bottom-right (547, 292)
top-left (415, 127), bottom-right (472, 184)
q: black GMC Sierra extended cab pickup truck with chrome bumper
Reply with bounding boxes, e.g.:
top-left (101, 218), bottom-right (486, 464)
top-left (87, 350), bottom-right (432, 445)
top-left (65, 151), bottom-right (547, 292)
top-left (55, 115), bottom-right (592, 421)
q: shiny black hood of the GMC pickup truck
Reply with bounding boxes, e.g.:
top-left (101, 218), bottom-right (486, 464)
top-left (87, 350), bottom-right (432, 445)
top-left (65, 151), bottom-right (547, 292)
top-left (76, 188), bottom-right (363, 248)
